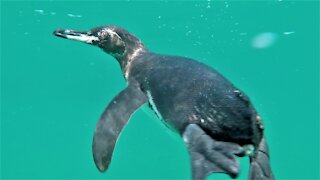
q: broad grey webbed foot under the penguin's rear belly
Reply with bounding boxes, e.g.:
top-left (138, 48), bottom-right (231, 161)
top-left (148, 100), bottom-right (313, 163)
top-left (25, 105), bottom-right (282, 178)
top-left (183, 124), bottom-right (244, 180)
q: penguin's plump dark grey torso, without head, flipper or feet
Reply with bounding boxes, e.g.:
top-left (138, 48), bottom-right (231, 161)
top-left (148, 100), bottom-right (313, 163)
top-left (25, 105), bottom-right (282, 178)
top-left (143, 57), bottom-right (260, 145)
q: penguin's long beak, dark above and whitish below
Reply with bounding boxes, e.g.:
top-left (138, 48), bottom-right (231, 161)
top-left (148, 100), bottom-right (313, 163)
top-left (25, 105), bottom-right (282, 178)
top-left (53, 29), bottom-right (99, 44)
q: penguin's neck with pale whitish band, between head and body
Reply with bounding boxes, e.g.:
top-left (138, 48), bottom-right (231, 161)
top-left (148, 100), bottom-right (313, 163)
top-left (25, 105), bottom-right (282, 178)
top-left (115, 44), bottom-right (148, 80)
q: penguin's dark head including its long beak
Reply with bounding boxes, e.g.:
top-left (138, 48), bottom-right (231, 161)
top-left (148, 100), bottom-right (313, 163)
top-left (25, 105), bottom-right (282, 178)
top-left (53, 26), bottom-right (144, 58)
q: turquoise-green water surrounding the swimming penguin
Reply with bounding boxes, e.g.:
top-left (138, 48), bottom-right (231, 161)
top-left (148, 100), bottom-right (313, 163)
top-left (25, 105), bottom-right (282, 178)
top-left (1, 0), bottom-right (319, 179)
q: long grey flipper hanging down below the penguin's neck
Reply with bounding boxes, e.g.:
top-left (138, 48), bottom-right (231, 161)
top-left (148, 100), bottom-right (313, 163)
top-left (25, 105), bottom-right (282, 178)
top-left (92, 84), bottom-right (148, 172)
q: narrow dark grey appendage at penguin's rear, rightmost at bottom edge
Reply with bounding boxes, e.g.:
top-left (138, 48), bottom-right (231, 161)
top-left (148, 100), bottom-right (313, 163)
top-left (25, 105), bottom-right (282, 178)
top-left (249, 138), bottom-right (274, 180)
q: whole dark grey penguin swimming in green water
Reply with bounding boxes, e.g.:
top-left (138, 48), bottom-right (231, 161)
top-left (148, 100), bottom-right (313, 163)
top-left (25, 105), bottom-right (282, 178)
top-left (54, 26), bottom-right (273, 180)
